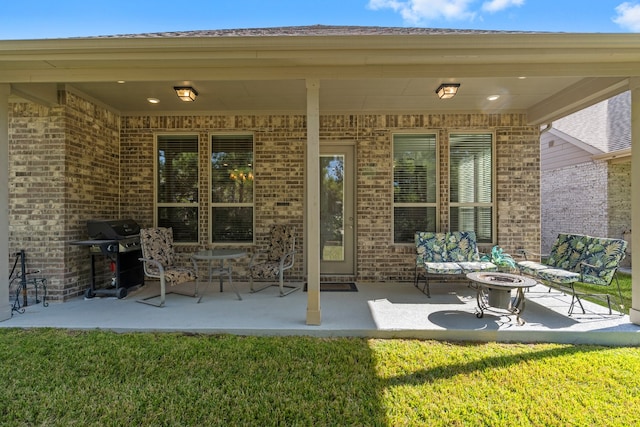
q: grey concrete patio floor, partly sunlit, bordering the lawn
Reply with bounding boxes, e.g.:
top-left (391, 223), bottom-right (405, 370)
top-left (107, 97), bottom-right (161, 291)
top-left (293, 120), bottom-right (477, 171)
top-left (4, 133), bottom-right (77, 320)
top-left (0, 282), bottom-right (640, 346)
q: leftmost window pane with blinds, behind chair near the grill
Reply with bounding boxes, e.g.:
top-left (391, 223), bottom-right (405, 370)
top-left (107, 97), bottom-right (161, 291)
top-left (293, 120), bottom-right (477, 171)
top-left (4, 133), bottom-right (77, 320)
top-left (156, 135), bottom-right (198, 243)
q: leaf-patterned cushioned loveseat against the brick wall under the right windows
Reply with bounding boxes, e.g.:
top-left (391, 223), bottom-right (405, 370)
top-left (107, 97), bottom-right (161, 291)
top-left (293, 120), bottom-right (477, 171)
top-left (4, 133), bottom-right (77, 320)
top-left (414, 231), bottom-right (498, 297)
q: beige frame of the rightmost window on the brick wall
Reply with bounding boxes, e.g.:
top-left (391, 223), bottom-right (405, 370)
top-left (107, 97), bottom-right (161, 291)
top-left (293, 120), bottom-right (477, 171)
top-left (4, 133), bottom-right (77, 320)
top-left (447, 129), bottom-right (498, 246)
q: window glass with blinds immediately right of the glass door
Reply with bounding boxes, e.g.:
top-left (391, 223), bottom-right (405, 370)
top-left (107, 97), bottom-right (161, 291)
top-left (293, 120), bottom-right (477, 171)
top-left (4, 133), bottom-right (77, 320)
top-left (393, 134), bottom-right (438, 243)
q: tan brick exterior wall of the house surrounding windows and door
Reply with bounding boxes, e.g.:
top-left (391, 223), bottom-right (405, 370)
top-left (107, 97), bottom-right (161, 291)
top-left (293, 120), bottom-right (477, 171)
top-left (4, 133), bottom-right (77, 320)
top-left (10, 94), bottom-right (540, 300)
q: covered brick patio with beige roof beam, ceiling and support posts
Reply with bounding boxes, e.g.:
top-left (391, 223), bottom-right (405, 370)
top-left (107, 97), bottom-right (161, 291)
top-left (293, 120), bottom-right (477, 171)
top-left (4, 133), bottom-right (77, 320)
top-left (0, 26), bottom-right (640, 328)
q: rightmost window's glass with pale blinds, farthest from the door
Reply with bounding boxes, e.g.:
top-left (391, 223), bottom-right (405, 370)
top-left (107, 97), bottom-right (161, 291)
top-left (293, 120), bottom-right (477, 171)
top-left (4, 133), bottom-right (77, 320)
top-left (449, 133), bottom-right (495, 243)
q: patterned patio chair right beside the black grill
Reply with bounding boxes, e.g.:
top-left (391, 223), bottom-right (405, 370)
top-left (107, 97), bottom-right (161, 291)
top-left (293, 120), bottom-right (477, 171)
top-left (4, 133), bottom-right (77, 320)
top-left (138, 227), bottom-right (198, 307)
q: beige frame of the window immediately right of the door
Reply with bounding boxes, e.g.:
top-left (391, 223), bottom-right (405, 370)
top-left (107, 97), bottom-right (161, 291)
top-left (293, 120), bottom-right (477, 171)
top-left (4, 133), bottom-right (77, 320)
top-left (390, 129), bottom-right (441, 246)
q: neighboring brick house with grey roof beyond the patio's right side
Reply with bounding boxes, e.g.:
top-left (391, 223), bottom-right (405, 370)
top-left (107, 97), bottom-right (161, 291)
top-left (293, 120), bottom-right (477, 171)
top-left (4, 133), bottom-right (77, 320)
top-left (540, 92), bottom-right (631, 266)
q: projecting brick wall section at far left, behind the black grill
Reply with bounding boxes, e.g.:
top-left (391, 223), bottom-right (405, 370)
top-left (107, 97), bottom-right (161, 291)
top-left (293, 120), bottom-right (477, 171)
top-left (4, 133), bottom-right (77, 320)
top-left (9, 92), bottom-right (120, 301)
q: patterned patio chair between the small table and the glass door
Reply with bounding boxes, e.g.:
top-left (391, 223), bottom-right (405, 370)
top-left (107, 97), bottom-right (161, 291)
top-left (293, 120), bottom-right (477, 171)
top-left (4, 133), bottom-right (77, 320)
top-left (249, 225), bottom-right (300, 297)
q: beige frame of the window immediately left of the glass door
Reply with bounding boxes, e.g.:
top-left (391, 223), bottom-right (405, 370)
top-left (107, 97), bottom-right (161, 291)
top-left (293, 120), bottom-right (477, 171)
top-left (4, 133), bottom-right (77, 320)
top-left (207, 132), bottom-right (256, 246)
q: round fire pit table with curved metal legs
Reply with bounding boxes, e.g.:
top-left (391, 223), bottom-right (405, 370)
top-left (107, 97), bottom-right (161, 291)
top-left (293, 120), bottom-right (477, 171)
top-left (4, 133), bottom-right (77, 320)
top-left (467, 272), bottom-right (537, 325)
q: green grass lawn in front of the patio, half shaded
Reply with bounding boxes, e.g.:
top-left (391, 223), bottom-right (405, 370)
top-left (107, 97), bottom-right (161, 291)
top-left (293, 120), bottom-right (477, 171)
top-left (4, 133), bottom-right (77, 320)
top-left (0, 329), bottom-right (640, 426)
